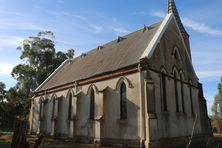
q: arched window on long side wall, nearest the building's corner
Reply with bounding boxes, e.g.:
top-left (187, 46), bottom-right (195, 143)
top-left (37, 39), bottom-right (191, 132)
top-left (120, 82), bottom-right (127, 119)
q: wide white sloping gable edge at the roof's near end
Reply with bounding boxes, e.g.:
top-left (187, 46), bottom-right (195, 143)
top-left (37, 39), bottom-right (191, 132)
top-left (140, 13), bottom-right (173, 59)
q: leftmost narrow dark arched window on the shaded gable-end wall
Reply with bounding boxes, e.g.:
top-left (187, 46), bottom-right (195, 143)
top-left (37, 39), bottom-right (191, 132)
top-left (161, 72), bottom-right (167, 111)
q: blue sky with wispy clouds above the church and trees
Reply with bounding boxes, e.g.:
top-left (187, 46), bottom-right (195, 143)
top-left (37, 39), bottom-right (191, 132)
top-left (0, 0), bottom-right (222, 114)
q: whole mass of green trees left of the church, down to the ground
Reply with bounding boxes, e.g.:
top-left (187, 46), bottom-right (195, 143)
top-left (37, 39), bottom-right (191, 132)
top-left (0, 31), bottom-right (74, 127)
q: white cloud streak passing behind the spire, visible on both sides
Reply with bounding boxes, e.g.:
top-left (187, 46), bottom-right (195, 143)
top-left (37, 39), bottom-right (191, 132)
top-left (149, 11), bottom-right (222, 36)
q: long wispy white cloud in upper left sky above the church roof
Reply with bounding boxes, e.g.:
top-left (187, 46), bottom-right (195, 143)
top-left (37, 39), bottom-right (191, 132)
top-left (34, 8), bottom-right (130, 34)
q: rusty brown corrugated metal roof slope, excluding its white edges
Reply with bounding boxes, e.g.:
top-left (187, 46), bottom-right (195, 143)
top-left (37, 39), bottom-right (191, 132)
top-left (37, 22), bottom-right (161, 91)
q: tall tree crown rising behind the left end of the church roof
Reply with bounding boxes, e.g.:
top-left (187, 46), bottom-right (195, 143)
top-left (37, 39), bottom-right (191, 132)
top-left (12, 31), bottom-right (74, 98)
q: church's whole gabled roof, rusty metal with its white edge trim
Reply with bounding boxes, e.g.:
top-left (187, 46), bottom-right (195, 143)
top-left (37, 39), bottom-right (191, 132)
top-left (35, 13), bottom-right (197, 92)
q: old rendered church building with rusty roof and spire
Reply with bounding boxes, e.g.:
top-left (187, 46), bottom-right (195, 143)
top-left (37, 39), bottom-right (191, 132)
top-left (30, 0), bottom-right (212, 148)
